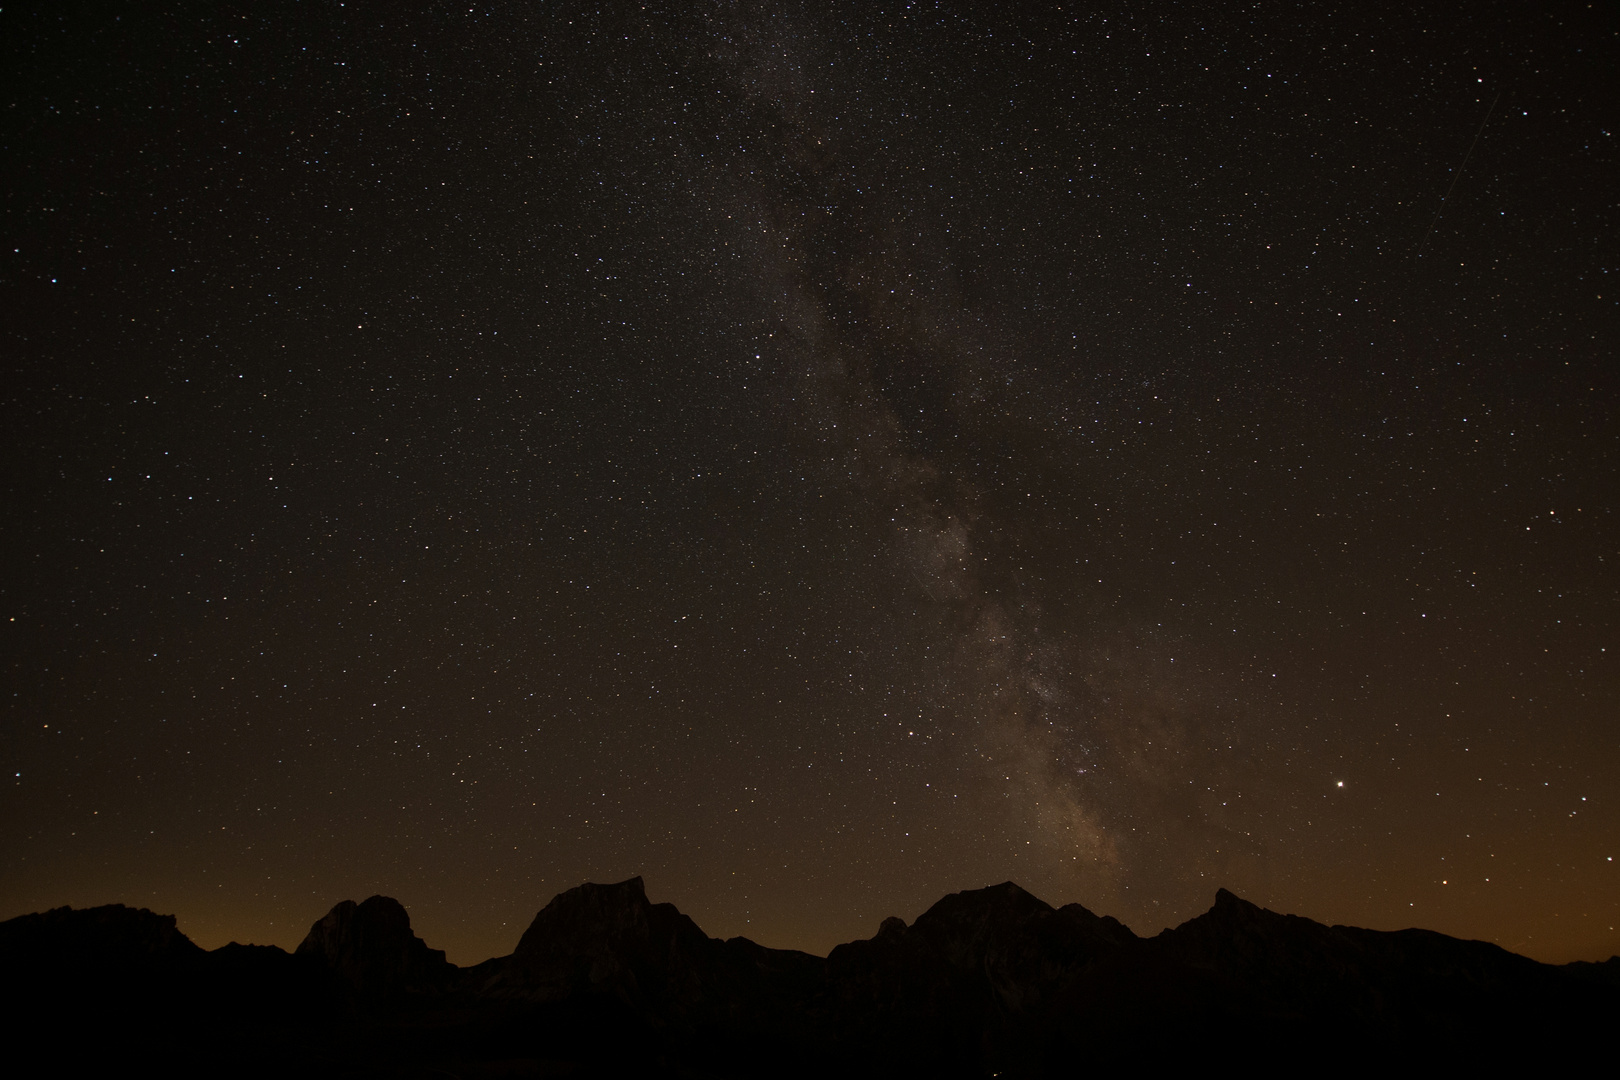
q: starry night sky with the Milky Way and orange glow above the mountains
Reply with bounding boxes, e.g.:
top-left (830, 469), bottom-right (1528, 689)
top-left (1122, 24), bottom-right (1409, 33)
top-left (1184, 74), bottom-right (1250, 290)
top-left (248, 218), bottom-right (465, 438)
top-left (0, 0), bottom-right (1620, 963)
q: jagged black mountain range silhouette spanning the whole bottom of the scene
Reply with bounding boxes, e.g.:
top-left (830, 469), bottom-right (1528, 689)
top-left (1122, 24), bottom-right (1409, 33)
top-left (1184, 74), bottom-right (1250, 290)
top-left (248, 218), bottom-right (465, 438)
top-left (0, 878), bottom-right (1620, 1077)
